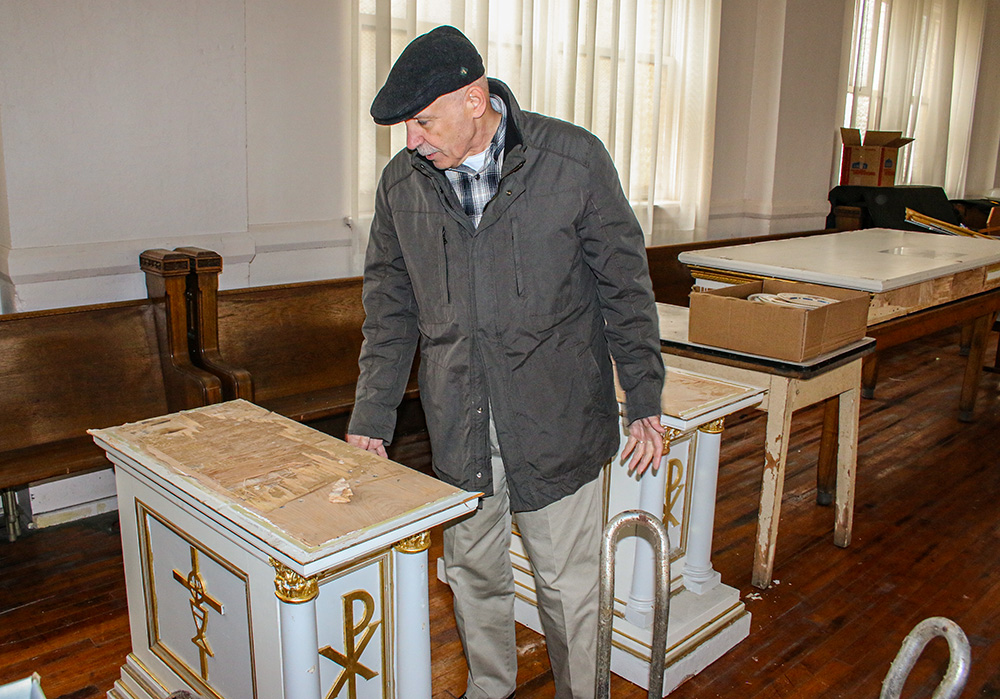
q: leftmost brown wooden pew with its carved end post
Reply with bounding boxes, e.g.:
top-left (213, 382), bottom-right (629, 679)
top-left (0, 250), bottom-right (222, 536)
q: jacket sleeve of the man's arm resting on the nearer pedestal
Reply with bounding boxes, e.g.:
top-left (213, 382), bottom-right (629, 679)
top-left (347, 181), bottom-right (419, 444)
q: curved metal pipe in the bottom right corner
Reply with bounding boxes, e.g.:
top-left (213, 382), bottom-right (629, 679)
top-left (879, 616), bottom-right (971, 699)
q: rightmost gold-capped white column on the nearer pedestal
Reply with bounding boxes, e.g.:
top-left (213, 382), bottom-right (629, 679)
top-left (392, 532), bottom-right (431, 699)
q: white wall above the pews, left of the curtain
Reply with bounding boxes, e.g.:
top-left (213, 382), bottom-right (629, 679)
top-left (0, 0), bottom-right (355, 312)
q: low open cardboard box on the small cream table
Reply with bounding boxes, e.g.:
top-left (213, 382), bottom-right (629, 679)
top-left (688, 279), bottom-right (870, 363)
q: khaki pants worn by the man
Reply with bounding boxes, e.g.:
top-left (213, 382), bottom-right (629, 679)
top-left (444, 424), bottom-right (602, 699)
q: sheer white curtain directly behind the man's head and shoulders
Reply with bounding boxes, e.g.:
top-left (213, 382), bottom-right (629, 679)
top-left (355, 0), bottom-right (721, 242)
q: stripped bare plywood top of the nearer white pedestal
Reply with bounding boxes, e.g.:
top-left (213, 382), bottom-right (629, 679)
top-left (94, 400), bottom-right (473, 547)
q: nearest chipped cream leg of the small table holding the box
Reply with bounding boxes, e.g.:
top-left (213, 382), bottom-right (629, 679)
top-left (752, 376), bottom-right (793, 589)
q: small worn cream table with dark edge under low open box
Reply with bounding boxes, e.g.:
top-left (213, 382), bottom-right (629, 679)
top-left (656, 304), bottom-right (875, 588)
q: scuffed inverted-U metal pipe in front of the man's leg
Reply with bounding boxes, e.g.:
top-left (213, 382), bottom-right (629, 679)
top-left (595, 510), bottom-right (670, 699)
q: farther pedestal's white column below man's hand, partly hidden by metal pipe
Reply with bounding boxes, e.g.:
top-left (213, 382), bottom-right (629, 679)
top-left (625, 428), bottom-right (680, 629)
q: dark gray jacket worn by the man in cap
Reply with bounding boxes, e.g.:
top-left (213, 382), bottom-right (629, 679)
top-left (348, 80), bottom-right (663, 511)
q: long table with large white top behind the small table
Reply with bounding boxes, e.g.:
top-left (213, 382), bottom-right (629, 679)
top-left (678, 228), bottom-right (1000, 421)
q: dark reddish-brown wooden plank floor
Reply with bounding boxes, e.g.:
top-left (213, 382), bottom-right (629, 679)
top-left (0, 333), bottom-right (1000, 699)
